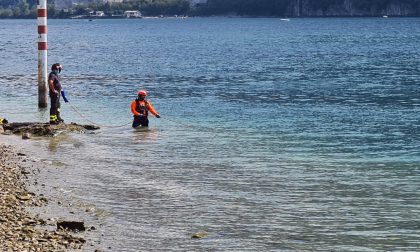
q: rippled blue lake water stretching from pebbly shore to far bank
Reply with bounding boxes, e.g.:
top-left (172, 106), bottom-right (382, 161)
top-left (0, 18), bottom-right (420, 251)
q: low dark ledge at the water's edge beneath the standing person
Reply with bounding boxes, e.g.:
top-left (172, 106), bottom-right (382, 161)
top-left (0, 122), bottom-right (100, 136)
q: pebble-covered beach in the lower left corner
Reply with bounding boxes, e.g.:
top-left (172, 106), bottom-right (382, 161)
top-left (0, 143), bottom-right (86, 252)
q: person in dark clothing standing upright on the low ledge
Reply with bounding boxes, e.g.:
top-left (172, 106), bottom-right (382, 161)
top-left (48, 63), bottom-right (64, 124)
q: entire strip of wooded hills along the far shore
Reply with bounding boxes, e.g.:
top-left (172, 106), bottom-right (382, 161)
top-left (0, 0), bottom-right (420, 18)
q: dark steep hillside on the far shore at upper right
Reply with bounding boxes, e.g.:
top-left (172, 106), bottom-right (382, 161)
top-left (195, 0), bottom-right (420, 17)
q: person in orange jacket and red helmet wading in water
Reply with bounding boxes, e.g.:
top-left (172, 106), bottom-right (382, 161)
top-left (131, 90), bottom-right (160, 128)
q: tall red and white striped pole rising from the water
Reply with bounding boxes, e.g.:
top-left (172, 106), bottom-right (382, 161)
top-left (37, 0), bottom-right (48, 108)
